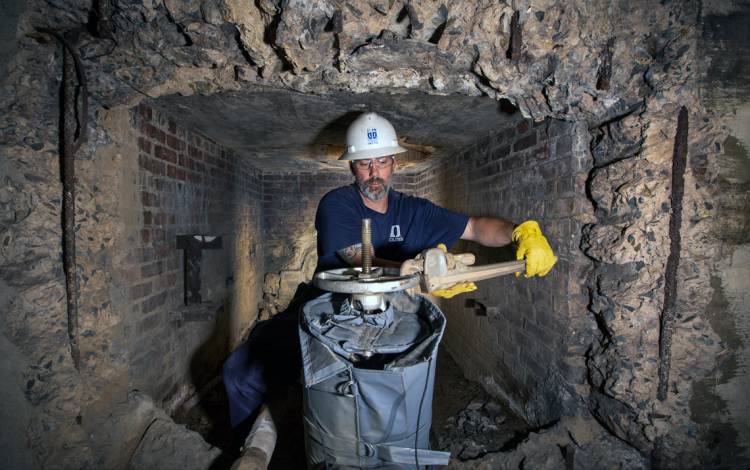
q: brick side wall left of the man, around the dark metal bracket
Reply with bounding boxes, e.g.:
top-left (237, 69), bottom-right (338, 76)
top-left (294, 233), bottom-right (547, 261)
top-left (126, 104), bottom-right (264, 399)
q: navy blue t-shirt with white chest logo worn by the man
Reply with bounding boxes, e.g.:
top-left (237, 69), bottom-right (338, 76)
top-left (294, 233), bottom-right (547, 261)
top-left (315, 184), bottom-right (469, 271)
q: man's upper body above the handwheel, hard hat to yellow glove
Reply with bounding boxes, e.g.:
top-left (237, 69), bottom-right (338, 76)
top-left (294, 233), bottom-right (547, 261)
top-left (315, 113), bottom-right (557, 284)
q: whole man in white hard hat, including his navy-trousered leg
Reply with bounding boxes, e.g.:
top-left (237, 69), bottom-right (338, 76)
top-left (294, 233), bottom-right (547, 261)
top-left (224, 113), bottom-right (557, 450)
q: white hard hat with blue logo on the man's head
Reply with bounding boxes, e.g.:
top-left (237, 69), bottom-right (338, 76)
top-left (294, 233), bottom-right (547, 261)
top-left (339, 113), bottom-right (407, 160)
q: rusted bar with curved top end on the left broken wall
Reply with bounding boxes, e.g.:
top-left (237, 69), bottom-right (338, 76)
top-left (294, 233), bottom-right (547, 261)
top-left (38, 28), bottom-right (88, 369)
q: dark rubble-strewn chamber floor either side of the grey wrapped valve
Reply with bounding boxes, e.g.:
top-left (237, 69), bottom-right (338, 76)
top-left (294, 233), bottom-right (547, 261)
top-left (173, 348), bottom-right (529, 470)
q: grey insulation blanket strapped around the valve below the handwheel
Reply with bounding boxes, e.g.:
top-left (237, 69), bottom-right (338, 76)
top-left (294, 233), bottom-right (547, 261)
top-left (299, 292), bottom-right (450, 469)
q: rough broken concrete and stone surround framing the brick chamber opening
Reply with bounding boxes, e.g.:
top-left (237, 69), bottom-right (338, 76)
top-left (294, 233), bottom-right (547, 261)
top-left (0, 0), bottom-right (750, 468)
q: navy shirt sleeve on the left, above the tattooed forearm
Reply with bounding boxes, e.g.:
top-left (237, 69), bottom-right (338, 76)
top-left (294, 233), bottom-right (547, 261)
top-left (315, 192), bottom-right (362, 271)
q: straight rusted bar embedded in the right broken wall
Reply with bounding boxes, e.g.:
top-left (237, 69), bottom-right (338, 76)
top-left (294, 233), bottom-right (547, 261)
top-left (656, 106), bottom-right (688, 401)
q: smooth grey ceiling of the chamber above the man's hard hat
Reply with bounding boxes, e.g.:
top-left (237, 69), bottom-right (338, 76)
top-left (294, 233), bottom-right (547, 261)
top-left (153, 90), bottom-right (513, 171)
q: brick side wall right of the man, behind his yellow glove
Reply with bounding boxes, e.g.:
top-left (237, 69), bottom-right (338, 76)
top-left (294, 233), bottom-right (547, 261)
top-left (415, 116), bottom-right (591, 423)
